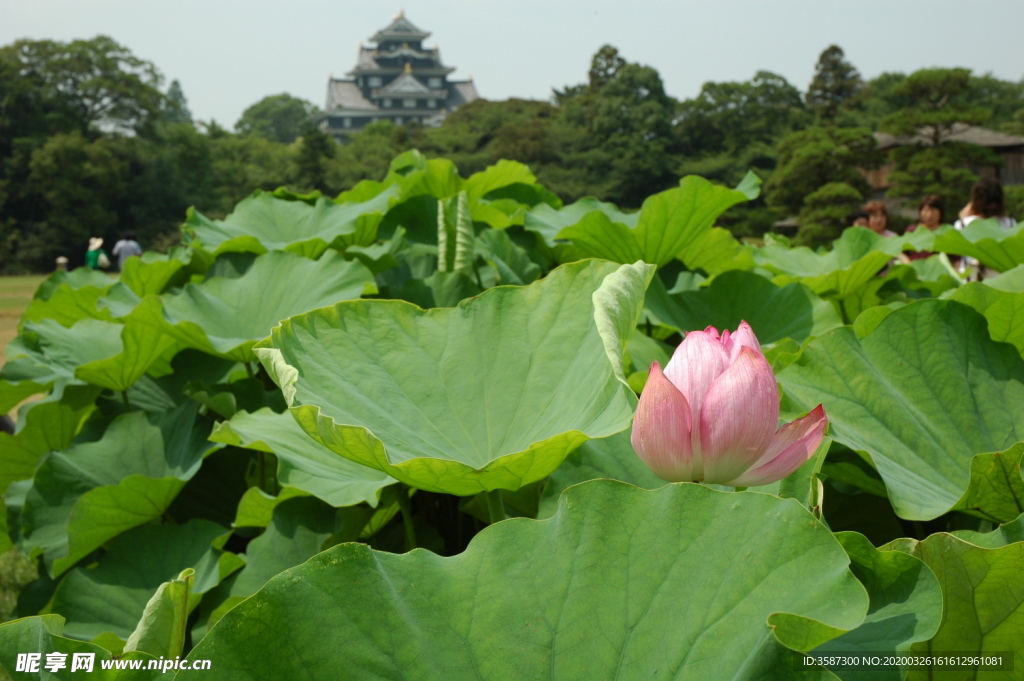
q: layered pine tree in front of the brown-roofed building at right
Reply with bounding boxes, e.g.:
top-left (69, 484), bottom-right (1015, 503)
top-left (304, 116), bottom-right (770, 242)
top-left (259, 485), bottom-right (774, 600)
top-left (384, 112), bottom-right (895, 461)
top-left (881, 69), bottom-right (1001, 205)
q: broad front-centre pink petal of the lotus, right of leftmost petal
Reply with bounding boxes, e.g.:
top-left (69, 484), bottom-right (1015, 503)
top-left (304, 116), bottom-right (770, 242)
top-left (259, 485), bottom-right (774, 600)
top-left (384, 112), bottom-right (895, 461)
top-left (697, 346), bottom-right (778, 483)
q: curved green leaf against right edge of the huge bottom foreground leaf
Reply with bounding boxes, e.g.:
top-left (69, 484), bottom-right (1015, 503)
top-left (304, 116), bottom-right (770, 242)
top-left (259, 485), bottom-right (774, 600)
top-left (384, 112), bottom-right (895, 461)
top-left (814, 533), bottom-right (942, 681)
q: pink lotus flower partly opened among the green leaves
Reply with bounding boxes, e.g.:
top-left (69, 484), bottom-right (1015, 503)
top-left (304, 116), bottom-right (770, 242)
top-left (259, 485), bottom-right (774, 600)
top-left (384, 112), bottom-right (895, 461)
top-left (633, 322), bottom-right (828, 486)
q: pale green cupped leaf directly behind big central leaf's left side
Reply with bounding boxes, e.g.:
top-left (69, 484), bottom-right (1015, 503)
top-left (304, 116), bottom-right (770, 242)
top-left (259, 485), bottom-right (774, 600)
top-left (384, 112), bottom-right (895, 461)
top-left (127, 251), bottom-right (376, 361)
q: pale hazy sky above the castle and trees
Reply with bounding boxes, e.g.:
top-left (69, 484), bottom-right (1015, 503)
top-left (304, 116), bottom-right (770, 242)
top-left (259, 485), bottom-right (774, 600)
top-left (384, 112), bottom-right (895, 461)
top-left (0, 0), bottom-right (1024, 127)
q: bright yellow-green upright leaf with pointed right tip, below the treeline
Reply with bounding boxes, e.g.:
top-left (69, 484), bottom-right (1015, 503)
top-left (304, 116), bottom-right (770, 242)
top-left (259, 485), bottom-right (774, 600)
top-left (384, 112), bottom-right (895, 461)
top-left (540, 175), bottom-right (759, 266)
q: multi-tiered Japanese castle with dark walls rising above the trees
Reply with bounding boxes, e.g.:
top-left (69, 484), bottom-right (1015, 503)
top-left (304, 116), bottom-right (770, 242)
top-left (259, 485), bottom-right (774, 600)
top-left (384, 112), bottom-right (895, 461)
top-left (319, 12), bottom-right (479, 140)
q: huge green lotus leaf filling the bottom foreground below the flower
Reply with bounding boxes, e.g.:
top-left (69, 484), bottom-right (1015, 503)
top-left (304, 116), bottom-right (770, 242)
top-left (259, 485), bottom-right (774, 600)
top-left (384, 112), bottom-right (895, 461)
top-left (177, 480), bottom-right (868, 681)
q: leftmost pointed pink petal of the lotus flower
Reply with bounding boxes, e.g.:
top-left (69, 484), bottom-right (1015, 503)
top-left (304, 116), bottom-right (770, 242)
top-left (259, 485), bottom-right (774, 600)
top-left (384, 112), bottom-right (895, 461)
top-left (633, 361), bottom-right (693, 482)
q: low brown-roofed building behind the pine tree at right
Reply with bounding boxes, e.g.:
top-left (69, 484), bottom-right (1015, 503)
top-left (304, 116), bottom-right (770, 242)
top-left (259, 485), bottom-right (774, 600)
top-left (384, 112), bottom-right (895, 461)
top-left (860, 123), bottom-right (1024, 189)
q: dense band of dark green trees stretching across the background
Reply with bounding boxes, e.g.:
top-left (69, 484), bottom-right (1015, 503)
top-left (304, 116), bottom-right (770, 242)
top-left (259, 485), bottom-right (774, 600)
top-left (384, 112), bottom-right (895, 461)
top-left (0, 37), bottom-right (1024, 272)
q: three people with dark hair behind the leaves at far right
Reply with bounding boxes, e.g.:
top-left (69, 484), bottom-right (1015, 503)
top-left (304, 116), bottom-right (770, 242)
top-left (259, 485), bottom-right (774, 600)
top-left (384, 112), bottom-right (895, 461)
top-left (849, 178), bottom-right (1017, 238)
